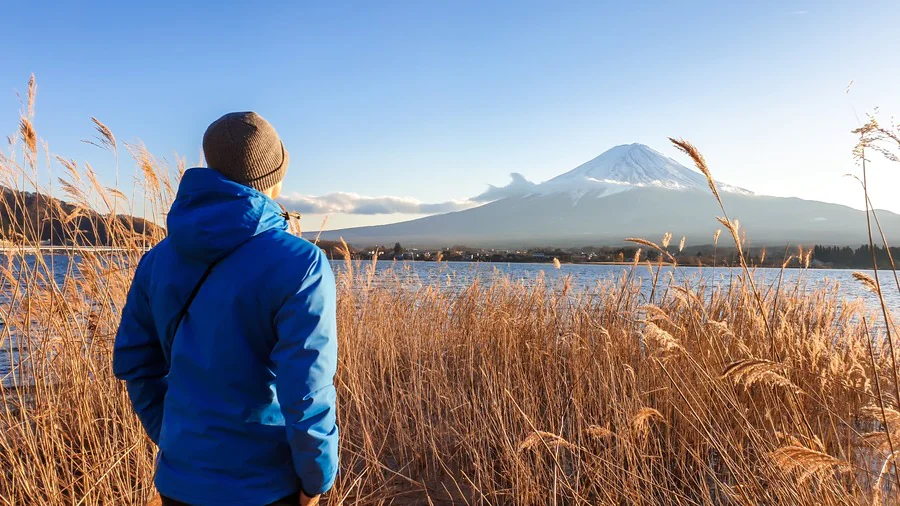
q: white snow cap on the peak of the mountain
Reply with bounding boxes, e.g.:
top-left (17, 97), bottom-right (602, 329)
top-left (536, 143), bottom-right (751, 197)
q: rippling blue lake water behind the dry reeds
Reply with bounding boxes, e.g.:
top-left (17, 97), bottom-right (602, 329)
top-left (0, 256), bottom-right (900, 385)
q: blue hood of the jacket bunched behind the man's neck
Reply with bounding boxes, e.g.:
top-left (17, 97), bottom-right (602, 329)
top-left (166, 168), bottom-right (288, 262)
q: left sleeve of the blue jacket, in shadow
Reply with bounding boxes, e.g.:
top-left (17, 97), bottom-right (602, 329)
top-left (113, 261), bottom-right (169, 444)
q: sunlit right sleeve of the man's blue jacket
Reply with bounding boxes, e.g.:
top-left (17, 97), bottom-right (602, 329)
top-left (272, 251), bottom-right (338, 496)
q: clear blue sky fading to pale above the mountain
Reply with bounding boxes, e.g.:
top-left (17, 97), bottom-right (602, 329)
top-left (0, 0), bottom-right (900, 228)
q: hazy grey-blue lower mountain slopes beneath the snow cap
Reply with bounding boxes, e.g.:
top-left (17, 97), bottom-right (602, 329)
top-left (323, 188), bottom-right (900, 247)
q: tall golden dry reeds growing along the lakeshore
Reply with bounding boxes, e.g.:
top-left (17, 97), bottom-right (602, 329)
top-left (0, 77), bottom-right (900, 505)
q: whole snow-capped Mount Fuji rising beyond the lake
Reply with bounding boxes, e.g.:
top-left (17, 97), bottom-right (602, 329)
top-left (312, 144), bottom-right (900, 248)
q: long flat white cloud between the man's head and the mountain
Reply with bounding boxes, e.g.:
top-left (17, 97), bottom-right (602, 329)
top-left (278, 192), bottom-right (477, 215)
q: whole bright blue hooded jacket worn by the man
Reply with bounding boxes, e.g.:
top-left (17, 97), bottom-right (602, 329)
top-left (113, 168), bottom-right (338, 506)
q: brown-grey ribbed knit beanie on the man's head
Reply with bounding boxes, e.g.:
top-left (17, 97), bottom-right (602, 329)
top-left (203, 112), bottom-right (290, 191)
